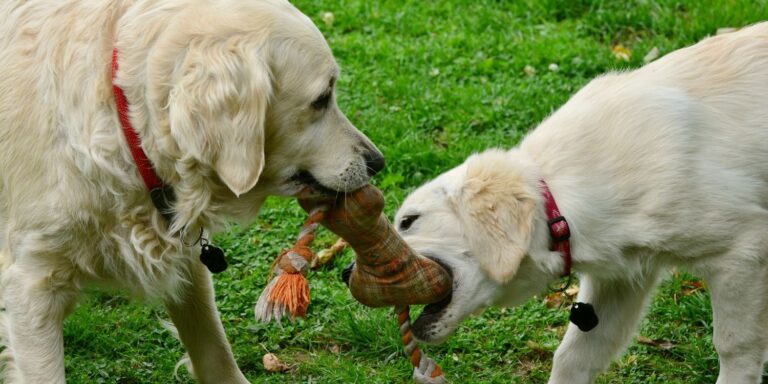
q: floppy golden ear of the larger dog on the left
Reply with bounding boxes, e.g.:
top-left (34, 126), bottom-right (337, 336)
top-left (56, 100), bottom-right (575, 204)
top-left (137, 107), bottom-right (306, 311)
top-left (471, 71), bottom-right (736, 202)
top-left (169, 41), bottom-right (272, 196)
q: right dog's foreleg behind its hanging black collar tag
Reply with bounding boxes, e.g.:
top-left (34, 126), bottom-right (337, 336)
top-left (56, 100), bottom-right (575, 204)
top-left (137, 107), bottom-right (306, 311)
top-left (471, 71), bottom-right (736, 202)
top-left (549, 272), bottom-right (657, 384)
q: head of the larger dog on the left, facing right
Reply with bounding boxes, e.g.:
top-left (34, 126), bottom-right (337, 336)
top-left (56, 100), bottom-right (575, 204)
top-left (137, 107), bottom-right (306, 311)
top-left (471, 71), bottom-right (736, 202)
top-left (118, 0), bottom-right (384, 228)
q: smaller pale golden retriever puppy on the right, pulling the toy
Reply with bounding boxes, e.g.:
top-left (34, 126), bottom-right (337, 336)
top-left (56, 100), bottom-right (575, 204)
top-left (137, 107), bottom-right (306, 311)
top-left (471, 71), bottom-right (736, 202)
top-left (396, 23), bottom-right (768, 384)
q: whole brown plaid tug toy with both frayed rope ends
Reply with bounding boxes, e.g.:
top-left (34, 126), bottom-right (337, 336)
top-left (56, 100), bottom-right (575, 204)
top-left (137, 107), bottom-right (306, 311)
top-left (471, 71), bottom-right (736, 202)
top-left (256, 185), bottom-right (453, 384)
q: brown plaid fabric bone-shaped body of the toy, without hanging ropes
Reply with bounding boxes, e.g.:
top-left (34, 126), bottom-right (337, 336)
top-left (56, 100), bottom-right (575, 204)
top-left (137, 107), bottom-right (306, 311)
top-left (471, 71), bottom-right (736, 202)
top-left (299, 185), bottom-right (453, 307)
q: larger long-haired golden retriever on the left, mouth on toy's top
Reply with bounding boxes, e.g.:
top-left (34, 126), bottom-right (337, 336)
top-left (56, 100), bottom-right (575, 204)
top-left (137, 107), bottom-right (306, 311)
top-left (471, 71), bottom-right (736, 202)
top-left (0, 0), bottom-right (384, 384)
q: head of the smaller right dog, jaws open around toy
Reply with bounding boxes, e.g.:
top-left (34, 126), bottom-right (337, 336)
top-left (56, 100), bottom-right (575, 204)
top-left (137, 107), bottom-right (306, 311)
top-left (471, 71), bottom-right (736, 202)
top-left (395, 150), bottom-right (552, 342)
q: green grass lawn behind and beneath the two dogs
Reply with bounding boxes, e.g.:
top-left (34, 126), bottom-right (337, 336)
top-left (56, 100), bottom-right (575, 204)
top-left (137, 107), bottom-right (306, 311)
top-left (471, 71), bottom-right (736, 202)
top-left (64, 0), bottom-right (768, 383)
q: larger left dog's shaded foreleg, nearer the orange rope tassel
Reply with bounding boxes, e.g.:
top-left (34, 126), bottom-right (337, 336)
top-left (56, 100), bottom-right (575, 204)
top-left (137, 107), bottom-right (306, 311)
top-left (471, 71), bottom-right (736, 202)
top-left (166, 262), bottom-right (248, 384)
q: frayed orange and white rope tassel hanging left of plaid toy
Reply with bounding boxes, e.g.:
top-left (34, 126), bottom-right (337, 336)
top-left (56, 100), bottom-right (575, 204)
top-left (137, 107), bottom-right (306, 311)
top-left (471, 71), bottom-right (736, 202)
top-left (254, 207), bottom-right (325, 323)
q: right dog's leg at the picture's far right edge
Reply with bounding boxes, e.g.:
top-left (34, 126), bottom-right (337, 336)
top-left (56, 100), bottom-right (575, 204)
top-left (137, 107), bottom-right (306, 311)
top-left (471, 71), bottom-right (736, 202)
top-left (706, 257), bottom-right (768, 384)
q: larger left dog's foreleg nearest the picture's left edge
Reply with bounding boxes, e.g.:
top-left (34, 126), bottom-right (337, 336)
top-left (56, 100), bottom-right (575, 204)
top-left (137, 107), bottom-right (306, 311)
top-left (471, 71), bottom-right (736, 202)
top-left (3, 265), bottom-right (77, 384)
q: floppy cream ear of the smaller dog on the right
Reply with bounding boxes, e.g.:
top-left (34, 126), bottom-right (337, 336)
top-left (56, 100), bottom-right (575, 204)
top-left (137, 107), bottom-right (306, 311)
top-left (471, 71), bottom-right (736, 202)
top-left (454, 150), bottom-right (536, 283)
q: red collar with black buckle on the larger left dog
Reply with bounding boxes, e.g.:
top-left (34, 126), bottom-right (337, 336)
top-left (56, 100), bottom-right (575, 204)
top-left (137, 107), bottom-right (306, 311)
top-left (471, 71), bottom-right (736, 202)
top-left (112, 48), bottom-right (175, 222)
